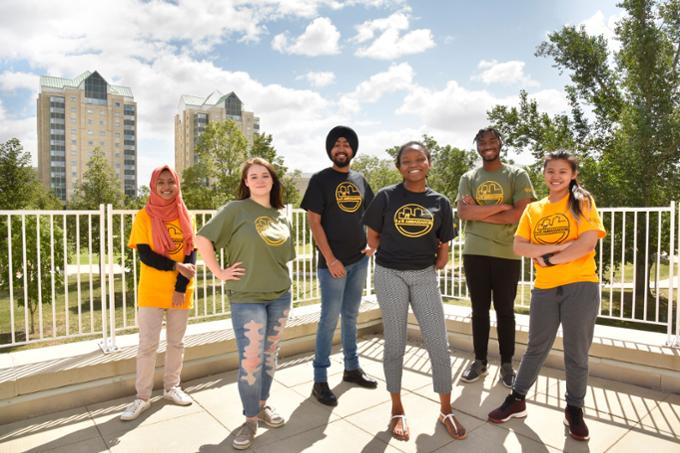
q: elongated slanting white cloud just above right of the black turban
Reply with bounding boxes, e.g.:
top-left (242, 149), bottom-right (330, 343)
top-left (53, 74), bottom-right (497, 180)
top-left (340, 63), bottom-right (413, 112)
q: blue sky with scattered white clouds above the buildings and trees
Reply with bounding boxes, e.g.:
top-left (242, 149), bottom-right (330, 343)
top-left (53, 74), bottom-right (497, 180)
top-left (0, 0), bottom-right (620, 185)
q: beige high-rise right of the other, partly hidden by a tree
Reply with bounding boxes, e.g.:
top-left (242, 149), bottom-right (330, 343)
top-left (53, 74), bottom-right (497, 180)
top-left (175, 91), bottom-right (260, 177)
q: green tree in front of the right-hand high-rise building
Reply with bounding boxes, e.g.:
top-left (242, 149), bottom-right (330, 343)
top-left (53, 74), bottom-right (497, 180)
top-left (182, 120), bottom-right (248, 209)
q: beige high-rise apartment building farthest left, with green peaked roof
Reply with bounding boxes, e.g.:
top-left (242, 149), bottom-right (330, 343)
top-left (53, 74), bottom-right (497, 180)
top-left (37, 71), bottom-right (137, 201)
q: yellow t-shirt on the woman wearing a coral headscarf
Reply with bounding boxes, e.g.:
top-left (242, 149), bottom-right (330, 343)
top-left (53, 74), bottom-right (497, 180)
top-left (128, 208), bottom-right (195, 309)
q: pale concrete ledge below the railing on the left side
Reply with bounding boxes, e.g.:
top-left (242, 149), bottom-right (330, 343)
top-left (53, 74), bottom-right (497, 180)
top-left (0, 301), bottom-right (382, 424)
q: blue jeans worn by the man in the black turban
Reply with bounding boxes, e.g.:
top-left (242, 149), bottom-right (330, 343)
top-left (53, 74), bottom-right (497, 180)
top-left (314, 257), bottom-right (368, 382)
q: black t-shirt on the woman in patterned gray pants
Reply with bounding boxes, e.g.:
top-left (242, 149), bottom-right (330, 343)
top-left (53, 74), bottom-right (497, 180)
top-left (363, 184), bottom-right (455, 270)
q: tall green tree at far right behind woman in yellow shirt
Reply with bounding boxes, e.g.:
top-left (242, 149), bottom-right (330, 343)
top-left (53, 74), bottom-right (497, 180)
top-left (489, 0), bottom-right (680, 304)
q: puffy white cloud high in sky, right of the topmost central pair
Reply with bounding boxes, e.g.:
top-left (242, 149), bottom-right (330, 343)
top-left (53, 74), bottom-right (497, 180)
top-left (352, 12), bottom-right (435, 60)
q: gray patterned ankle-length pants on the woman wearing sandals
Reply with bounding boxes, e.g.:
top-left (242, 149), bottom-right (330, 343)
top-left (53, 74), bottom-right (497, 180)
top-left (375, 265), bottom-right (451, 394)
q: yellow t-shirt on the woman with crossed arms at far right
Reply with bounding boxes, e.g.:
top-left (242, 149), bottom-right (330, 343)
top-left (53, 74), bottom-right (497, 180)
top-left (515, 195), bottom-right (606, 289)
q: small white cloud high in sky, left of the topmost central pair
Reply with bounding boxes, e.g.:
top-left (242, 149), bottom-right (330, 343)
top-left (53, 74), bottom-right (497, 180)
top-left (272, 17), bottom-right (340, 57)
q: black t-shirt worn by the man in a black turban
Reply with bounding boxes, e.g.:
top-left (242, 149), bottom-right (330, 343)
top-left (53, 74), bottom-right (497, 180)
top-left (300, 168), bottom-right (373, 268)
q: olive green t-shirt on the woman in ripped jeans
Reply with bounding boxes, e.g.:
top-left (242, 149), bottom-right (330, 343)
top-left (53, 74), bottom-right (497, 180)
top-left (198, 198), bottom-right (295, 303)
